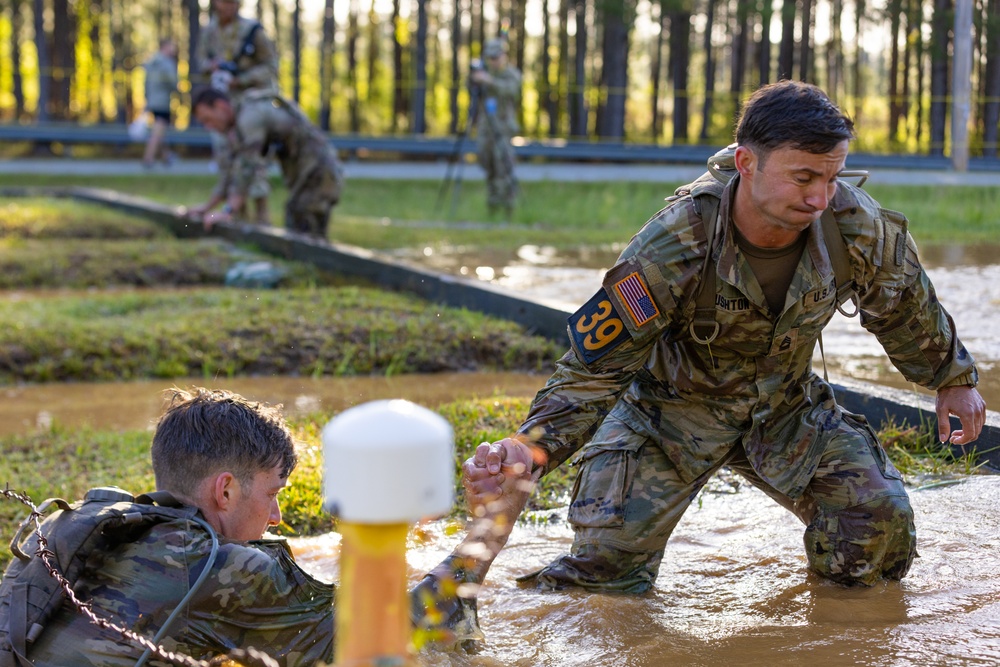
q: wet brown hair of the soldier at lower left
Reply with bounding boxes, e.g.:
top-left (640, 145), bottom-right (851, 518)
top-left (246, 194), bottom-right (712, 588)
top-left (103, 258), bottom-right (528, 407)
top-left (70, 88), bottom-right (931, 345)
top-left (151, 387), bottom-right (298, 497)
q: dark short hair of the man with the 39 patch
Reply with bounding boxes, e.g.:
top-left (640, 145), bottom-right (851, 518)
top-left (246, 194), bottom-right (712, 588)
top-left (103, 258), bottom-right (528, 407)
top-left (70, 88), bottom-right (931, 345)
top-left (736, 80), bottom-right (854, 157)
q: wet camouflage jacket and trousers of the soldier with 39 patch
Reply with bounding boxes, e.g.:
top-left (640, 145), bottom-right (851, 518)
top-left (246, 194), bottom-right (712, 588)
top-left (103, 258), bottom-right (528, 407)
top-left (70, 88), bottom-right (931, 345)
top-left (519, 152), bottom-right (978, 592)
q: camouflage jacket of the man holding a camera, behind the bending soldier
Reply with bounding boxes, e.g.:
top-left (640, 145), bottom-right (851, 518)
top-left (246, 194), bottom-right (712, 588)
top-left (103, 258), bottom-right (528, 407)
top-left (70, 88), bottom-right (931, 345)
top-left (192, 16), bottom-right (278, 101)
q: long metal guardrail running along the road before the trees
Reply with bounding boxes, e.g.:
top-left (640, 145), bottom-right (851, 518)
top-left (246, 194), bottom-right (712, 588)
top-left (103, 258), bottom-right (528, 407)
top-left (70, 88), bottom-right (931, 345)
top-left (0, 123), bottom-right (1000, 171)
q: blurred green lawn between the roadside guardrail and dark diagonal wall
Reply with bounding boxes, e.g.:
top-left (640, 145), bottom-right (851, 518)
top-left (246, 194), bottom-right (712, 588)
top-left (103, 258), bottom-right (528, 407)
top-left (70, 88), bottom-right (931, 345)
top-left (4, 172), bottom-right (1000, 249)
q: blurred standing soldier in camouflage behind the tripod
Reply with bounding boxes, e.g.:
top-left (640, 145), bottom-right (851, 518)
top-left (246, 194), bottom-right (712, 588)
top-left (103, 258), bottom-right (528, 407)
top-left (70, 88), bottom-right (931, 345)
top-left (469, 39), bottom-right (521, 217)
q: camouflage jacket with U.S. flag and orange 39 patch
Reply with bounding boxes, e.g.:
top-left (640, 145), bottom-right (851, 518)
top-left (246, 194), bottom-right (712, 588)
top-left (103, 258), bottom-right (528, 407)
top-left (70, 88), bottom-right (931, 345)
top-left (519, 150), bottom-right (976, 497)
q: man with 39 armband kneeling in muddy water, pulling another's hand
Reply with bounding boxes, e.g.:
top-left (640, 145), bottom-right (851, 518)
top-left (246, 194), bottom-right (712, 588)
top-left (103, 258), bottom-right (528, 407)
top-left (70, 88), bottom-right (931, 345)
top-left (448, 81), bottom-right (985, 604)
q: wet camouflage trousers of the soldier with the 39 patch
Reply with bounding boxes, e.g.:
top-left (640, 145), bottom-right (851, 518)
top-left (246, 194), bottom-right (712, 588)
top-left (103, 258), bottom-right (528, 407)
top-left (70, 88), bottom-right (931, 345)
top-left (523, 414), bottom-right (916, 593)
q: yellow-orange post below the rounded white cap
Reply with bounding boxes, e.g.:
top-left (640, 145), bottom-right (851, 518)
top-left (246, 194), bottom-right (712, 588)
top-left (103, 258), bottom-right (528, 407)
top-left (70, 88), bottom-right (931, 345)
top-left (335, 522), bottom-right (414, 667)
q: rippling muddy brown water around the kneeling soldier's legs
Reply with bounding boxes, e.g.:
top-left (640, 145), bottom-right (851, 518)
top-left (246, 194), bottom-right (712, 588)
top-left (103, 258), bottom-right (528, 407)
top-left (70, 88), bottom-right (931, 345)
top-left (294, 477), bottom-right (1000, 667)
